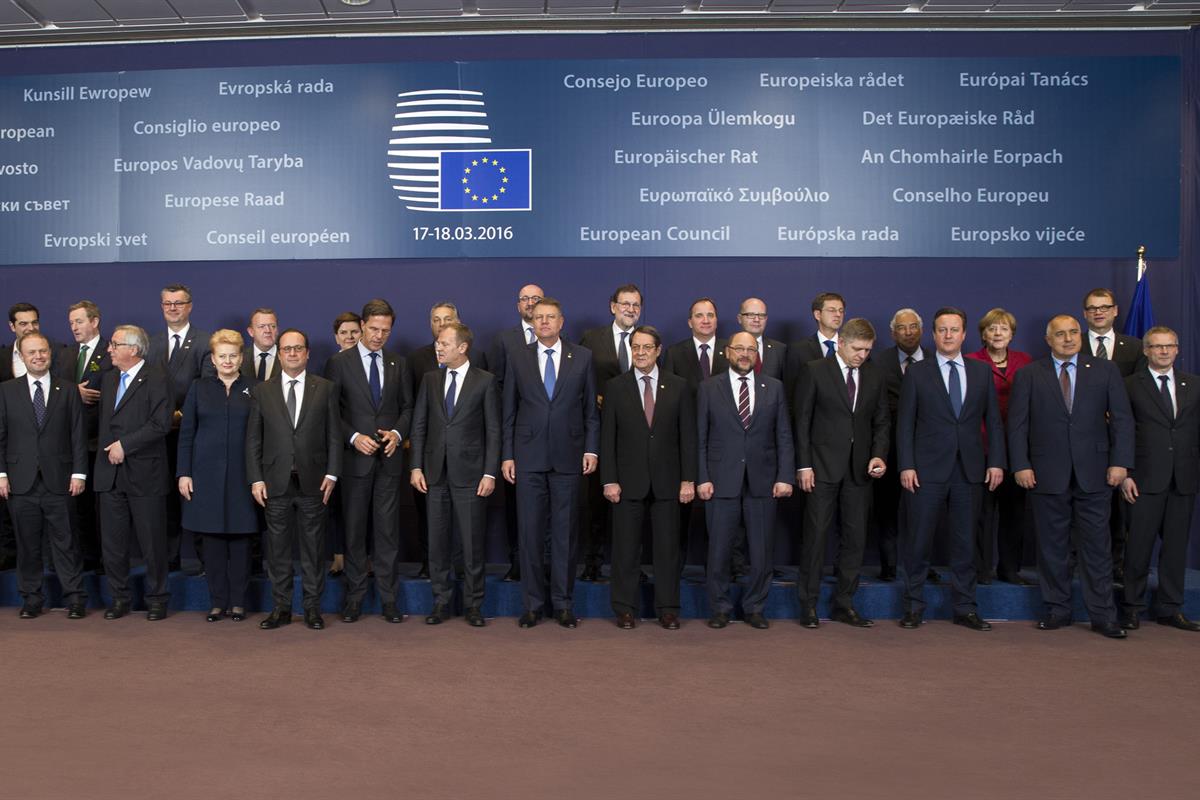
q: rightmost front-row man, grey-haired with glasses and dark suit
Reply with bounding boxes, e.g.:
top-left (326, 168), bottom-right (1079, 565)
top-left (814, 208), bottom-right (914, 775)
top-left (1121, 327), bottom-right (1200, 632)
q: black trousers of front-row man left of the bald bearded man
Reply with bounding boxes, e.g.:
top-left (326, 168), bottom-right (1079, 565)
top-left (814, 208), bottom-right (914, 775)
top-left (611, 491), bottom-right (682, 616)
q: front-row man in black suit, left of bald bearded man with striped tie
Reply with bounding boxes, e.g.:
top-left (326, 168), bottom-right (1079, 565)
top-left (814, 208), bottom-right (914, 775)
top-left (600, 325), bottom-right (696, 631)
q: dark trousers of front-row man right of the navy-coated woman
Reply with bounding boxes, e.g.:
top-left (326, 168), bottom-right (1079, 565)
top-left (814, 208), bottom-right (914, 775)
top-left (266, 475), bottom-right (326, 610)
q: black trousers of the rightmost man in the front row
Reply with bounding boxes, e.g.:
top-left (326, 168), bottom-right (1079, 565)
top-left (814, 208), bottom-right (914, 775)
top-left (1122, 485), bottom-right (1196, 616)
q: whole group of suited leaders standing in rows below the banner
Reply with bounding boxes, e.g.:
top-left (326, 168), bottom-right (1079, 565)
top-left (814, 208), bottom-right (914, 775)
top-left (0, 284), bottom-right (1200, 638)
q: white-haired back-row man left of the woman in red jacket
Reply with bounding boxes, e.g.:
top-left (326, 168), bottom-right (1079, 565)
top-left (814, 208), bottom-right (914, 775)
top-left (871, 308), bottom-right (938, 582)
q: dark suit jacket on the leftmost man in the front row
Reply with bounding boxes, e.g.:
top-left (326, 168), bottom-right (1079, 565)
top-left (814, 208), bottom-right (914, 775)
top-left (0, 377), bottom-right (88, 494)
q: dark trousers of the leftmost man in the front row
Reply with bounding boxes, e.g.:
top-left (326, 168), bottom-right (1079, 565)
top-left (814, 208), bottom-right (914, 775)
top-left (8, 475), bottom-right (86, 606)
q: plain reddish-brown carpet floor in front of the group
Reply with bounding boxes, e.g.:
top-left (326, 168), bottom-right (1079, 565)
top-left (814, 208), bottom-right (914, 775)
top-left (0, 609), bottom-right (1200, 800)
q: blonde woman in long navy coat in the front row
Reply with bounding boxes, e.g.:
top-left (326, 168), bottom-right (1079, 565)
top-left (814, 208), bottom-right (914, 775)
top-left (176, 330), bottom-right (258, 622)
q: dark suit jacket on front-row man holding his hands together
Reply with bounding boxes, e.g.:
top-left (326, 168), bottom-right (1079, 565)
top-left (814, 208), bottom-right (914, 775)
top-left (325, 345), bottom-right (413, 477)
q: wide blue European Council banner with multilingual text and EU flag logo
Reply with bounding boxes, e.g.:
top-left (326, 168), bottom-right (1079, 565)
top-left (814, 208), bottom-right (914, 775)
top-left (0, 55), bottom-right (1183, 264)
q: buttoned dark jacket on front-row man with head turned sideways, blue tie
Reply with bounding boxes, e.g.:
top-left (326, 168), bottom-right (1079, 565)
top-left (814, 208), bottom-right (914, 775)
top-left (409, 365), bottom-right (500, 487)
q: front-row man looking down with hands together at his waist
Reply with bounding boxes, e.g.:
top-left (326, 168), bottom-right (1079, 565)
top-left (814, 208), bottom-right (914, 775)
top-left (325, 299), bottom-right (413, 622)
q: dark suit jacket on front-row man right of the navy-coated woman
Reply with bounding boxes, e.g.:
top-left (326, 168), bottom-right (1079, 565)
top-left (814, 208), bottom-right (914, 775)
top-left (246, 372), bottom-right (343, 497)
